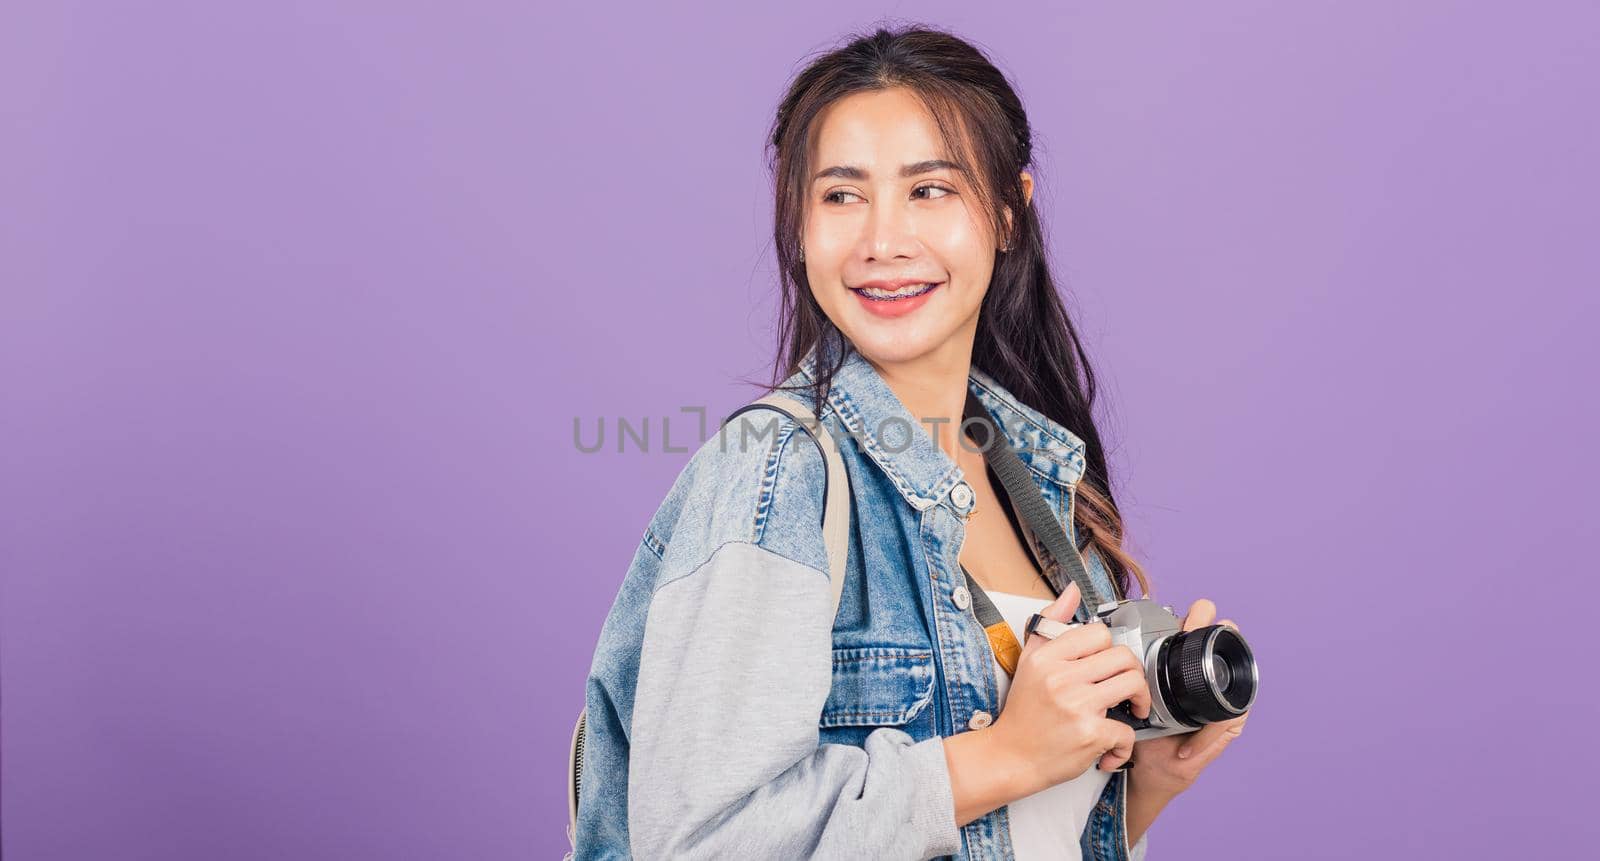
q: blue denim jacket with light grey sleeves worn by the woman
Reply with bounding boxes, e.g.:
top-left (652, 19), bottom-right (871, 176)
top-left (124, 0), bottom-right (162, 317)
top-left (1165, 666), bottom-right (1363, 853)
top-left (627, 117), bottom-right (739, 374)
top-left (574, 342), bottom-right (1146, 861)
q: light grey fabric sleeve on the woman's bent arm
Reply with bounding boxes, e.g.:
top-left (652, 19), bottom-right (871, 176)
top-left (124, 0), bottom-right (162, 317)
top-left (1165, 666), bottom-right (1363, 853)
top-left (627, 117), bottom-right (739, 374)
top-left (627, 537), bottom-right (960, 859)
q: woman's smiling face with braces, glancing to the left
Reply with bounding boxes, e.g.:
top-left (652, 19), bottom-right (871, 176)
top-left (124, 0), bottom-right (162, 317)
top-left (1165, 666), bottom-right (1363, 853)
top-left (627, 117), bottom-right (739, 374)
top-left (802, 88), bottom-right (1030, 365)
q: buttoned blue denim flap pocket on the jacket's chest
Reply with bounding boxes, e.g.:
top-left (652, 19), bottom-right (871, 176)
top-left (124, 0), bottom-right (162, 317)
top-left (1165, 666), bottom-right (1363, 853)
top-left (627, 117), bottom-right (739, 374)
top-left (818, 647), bottom-right (933, 728)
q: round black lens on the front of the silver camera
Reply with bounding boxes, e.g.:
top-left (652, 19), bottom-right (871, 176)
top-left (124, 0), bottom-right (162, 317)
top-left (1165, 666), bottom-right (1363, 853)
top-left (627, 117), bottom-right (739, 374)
top-left (1157, 624), bottom-right (1258, 727)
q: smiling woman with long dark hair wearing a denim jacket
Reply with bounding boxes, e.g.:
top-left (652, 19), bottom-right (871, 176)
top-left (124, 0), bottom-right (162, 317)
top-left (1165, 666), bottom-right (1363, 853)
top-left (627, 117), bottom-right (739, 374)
top-left (576, 29), bottom-right (1245, 858)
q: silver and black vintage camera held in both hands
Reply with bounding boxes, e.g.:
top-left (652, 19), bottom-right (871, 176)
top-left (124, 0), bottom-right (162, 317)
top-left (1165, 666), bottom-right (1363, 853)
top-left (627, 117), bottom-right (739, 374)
top-left (1029, 599), bottom-right (1261, 741)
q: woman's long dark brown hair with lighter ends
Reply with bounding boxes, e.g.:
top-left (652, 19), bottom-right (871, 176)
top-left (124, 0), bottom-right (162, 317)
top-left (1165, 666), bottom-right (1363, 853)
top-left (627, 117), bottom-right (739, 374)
top-left (768, 21), bottom-right (1149, 595)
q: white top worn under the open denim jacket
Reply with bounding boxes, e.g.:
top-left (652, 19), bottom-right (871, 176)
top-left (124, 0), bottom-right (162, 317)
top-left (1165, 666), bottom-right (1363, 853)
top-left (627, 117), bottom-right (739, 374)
top-left (986, 591), bottom-right (1110, 861)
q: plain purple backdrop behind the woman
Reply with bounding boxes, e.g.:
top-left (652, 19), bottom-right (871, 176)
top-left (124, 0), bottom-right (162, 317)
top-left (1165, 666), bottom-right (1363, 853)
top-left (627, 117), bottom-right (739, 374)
top-left (0, 0), bottom-right (1600, 861)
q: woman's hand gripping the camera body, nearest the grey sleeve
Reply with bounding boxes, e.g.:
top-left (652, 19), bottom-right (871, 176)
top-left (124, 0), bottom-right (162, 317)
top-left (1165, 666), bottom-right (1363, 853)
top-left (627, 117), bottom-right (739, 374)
top-left (990, 583), bottom-right (1150, 792)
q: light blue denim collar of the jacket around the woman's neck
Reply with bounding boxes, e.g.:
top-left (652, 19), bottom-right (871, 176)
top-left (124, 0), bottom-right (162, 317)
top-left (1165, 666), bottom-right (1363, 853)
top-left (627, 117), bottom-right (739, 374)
top-left (789, 337), bottom-right (1085, 511)
